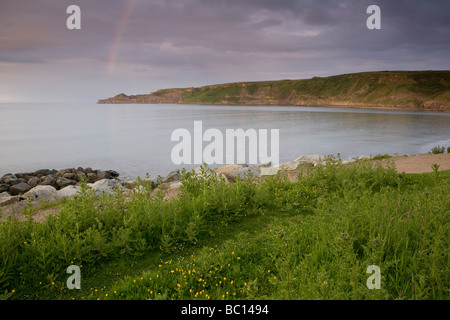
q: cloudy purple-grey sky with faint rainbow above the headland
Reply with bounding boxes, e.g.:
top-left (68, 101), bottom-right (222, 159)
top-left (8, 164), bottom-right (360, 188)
top-left (0, 0), bottom-right (450, 103)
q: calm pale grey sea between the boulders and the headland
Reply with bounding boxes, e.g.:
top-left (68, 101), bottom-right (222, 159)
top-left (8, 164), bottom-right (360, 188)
top-left (0, 104), bottom-right (450, 178)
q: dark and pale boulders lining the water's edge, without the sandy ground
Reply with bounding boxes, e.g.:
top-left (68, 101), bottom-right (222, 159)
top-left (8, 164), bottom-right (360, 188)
top-left (0, 155), bottom-right (368, 219)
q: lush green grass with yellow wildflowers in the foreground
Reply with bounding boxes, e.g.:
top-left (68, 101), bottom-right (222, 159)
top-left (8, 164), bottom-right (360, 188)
top-left (0, 161), bottom-right (450, 300)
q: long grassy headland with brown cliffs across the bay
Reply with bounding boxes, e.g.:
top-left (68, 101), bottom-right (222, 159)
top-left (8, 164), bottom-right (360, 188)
top-left (98, 71), bottom-right (450, 112)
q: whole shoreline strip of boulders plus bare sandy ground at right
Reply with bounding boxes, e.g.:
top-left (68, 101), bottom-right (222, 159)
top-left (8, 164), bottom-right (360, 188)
top-left (0, 153), bottom-right (450, 221)
